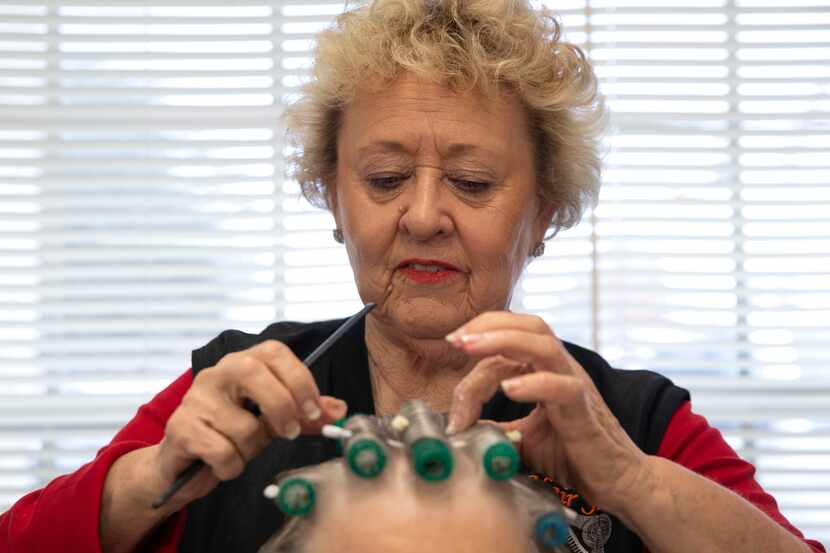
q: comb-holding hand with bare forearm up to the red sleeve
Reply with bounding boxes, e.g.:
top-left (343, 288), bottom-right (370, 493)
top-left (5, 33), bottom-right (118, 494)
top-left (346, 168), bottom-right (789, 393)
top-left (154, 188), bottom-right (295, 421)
top-left (98, 340), bottom-right (346, 553)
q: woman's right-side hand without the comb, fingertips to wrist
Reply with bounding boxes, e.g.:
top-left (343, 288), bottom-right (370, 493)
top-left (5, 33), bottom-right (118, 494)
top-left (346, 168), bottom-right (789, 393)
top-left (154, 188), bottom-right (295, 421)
top-left (447, 311), bottom-right (650, 513)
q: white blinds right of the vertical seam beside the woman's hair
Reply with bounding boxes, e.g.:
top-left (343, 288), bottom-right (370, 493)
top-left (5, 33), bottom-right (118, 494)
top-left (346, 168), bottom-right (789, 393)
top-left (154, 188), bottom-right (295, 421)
top-left (590, 0), bottom-right (830, 541)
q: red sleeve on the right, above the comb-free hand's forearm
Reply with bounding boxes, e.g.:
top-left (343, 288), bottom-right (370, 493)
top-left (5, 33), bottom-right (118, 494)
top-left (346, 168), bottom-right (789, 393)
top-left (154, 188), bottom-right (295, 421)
top-left (657, 401), bottom-right (825, 553)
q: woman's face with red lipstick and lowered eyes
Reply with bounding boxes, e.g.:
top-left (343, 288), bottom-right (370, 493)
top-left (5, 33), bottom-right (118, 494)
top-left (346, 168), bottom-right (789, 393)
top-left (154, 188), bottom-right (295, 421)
top-left (329, 76), bottom-right (552, 339)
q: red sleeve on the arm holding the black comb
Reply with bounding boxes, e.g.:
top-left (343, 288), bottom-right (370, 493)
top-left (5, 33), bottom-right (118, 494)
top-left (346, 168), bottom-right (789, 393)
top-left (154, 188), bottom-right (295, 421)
top-left (0, 370), bottom-right (193, 553)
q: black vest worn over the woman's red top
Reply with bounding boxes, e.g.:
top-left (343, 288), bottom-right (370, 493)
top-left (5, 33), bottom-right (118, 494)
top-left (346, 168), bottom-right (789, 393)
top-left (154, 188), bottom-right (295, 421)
top-left (179, 320), bottom-right (689, 553)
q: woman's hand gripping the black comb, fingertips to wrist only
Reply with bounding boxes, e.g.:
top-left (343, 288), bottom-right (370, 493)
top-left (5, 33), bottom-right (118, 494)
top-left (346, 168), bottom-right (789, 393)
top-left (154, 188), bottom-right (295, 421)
top-left (153, 340), bottom-right (347, 510)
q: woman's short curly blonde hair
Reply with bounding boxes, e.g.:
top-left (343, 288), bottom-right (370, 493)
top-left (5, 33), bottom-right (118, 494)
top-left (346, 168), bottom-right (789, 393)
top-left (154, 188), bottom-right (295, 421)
top-left (283, 0), bottom-right (606, 231)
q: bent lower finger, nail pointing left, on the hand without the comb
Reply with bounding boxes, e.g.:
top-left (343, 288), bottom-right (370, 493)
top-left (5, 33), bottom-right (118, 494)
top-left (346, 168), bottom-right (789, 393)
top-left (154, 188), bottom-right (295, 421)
top-left (501, 372), bottom-right (591, 426)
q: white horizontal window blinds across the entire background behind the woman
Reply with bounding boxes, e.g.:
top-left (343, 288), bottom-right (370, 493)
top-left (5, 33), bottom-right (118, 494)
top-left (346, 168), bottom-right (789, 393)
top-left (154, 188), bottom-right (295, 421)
top-left (0, 0), bottom-right (830, 541)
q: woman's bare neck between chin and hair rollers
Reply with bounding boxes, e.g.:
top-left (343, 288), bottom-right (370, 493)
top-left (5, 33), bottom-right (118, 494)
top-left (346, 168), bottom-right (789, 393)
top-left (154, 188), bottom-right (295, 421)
top-left (366, 317), bottom-right (475, 415)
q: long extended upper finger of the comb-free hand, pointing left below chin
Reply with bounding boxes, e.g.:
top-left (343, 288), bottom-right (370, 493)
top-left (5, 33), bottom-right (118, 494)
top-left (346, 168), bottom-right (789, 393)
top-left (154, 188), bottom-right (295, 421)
top-left (452, 329), bottom-right (581, 374)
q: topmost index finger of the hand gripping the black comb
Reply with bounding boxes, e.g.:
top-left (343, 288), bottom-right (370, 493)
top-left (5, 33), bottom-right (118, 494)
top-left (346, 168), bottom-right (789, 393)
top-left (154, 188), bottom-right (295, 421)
top-left (249, 340), bottom-right (321, 421)
